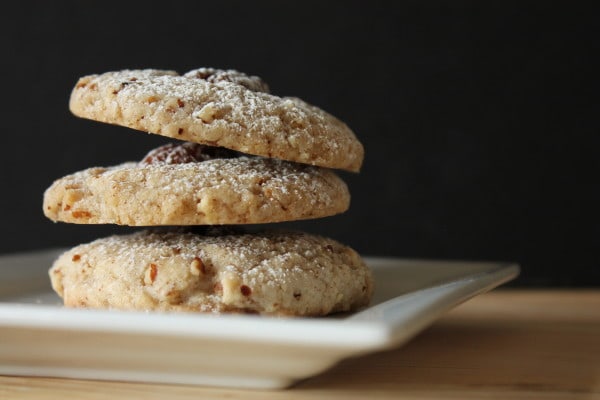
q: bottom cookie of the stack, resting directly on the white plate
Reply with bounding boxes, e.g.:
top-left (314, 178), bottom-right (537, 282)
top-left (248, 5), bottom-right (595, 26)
top-left (49, 231), bottom-right (373, 316)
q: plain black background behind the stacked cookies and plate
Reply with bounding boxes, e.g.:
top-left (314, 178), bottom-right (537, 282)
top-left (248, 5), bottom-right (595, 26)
top-left (0, 1), bottom-right (600, 286)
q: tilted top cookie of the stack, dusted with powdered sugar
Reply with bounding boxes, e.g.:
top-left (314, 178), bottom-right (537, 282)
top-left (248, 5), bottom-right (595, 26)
top-left (70, 68), bottom-right (364, 172)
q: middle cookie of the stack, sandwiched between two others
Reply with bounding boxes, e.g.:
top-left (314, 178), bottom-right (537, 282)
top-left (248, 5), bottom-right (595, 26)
top-left (43, 143), bottom-right (350, 226)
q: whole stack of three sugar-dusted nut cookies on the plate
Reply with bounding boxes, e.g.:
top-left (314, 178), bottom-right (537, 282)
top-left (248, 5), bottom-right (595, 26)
top-left (43, 68), bottom-right (373, 316)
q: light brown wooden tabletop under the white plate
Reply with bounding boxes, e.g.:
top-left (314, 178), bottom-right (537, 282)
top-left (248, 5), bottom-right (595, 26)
top-left (0, 289), bottom-right (600, 400)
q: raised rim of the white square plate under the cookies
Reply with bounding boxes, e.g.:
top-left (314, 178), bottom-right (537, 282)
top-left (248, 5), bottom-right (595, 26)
top-left (0, 253), bottom-right (520, 349)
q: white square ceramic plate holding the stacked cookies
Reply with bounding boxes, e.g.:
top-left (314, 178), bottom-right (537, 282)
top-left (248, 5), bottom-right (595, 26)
top-left (0, 251), bottom-right (519, 389)
